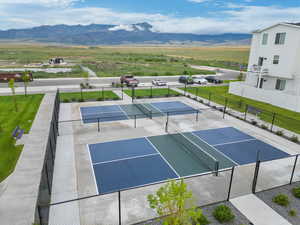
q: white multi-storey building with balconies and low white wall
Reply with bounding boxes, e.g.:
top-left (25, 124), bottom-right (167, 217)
top-left (229, 23), bottom-right (300, 112)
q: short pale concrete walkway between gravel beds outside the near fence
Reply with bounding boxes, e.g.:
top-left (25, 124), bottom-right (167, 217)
top-left (230, 194), bottom-right (291, 225)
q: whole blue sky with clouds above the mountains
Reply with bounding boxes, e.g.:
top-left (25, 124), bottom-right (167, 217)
top-left (0, 0), bottom-right (300, 34)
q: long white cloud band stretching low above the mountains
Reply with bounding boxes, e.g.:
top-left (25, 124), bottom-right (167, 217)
top-left (0, 3), bottom-right (300, 34)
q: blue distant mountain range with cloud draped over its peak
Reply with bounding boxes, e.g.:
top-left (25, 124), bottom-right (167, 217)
top-left (0, 23), bottom-right (251, 45)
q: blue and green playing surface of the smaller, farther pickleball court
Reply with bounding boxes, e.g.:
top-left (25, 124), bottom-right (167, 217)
top-left (80, 101), bottom-right (199, 123)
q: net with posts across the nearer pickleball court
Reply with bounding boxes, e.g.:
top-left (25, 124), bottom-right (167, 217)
top-left (167, 121), bottom-right (219, 173)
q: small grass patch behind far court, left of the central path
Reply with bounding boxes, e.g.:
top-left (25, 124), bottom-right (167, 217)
top-left (60, 90), bottom-right (120, 102)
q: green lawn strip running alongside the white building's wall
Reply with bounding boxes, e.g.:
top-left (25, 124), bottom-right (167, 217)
top-left (181, 86), bottom-right (300, 133)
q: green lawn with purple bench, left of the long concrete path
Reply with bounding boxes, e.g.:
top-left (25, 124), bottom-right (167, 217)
top-left (0, 95), bottom-right (43, 182)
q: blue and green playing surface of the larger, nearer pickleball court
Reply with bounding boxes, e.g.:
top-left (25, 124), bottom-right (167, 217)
top-left (88, 127), bottom-right (289, 194)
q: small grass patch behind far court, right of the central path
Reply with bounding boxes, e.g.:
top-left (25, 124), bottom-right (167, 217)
top-left (124, 88), bottom-right (180, 98)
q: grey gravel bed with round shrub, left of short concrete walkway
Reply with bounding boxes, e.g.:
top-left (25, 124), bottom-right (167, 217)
top-left (135, 202), bottom-right (250, 225)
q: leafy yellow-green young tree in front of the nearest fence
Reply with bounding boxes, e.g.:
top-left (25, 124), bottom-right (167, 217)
top-left (148, 180), bottom-right (209, 225)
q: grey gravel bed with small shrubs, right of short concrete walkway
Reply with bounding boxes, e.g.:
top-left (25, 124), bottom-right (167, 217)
top-left (256, 182), bottom-right (300, 225)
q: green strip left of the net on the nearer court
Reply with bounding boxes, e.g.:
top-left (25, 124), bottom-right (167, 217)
top-left (148, 135), bottom-right (211, 177)
